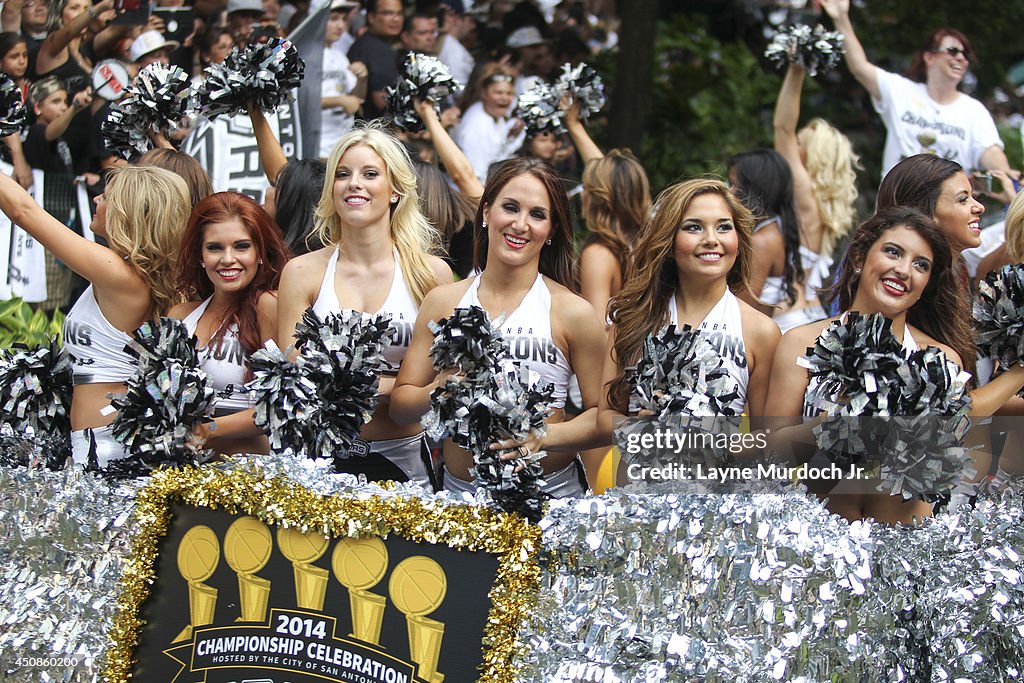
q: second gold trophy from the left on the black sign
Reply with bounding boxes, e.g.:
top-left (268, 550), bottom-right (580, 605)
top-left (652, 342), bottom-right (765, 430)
top-left (224, 517), bottom-right (273, 622)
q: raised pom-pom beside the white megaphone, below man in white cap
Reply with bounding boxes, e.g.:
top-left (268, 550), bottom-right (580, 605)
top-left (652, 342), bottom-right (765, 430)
top-left (100, 62), bottom-right (188, 159)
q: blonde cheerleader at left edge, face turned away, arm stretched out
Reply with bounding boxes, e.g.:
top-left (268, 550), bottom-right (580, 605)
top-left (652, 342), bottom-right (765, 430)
top-left (0, 167), bottom-right (189, 467)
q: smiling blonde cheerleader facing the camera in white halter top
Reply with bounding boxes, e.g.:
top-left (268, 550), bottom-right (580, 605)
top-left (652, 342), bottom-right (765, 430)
top-left (278, 124), bottom-right (452, 485)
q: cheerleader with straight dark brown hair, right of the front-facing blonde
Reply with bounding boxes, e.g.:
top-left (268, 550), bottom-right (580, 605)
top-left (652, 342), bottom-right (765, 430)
top-left (391, 158), bottom-right (604, 497)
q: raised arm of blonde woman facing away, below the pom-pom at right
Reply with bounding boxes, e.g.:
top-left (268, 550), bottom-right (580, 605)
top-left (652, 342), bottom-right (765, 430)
top-left (773, 65), bottom-right (821, 241)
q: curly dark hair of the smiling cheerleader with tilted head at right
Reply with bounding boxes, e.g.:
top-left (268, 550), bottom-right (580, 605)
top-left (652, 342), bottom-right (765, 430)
top-left (821, 207), bottom-right (976, 375)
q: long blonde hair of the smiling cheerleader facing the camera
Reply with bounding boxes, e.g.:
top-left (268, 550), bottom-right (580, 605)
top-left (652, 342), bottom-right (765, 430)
top-left (314, 122), bottom-right (440, 303)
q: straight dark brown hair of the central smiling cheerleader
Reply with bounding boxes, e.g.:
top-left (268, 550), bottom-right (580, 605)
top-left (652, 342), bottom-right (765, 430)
top-left (473, 157), bottom-right (575, 289)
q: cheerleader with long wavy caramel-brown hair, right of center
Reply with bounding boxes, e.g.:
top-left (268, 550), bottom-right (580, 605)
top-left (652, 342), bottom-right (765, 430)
top-left (600, 178), bottom-right (780, 438)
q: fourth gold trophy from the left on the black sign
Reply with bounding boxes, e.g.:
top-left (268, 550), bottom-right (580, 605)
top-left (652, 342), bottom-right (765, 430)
top-left (331, 537), bottom-right (388, 645)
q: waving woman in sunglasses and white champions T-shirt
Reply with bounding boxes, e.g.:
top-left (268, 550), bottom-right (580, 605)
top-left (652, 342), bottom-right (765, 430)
top-left (821, 0), bottom-right (1010, 176)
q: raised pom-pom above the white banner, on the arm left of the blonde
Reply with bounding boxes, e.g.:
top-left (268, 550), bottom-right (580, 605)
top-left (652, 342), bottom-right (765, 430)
top-left (195, 38), bottom-right (305, 119)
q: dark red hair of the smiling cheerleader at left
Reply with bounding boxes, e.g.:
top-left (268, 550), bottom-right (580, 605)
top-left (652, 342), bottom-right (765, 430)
top-left (178, 193), bottom-right (288, 353)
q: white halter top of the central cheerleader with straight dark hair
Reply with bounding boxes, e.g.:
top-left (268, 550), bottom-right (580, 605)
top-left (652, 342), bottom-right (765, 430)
top-left (459, 273), bottom-right (572, 409)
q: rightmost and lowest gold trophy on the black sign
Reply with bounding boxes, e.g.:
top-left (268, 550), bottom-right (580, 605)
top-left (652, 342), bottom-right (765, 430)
top-left (388, 555), bottom-right (447, 683)
